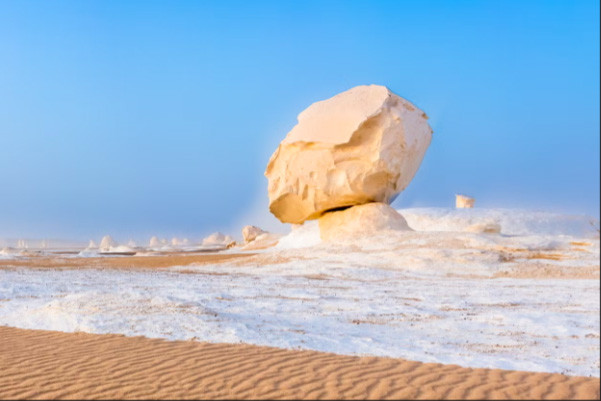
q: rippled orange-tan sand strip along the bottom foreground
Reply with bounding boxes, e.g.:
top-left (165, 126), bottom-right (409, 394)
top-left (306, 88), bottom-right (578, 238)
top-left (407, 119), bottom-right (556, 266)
top-left (0, 327), bottom-right (599, 399)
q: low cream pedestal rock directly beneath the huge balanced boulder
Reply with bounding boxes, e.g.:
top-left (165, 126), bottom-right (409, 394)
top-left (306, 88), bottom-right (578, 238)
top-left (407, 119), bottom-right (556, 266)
top-left (319, 202), bottom-right (412, 241)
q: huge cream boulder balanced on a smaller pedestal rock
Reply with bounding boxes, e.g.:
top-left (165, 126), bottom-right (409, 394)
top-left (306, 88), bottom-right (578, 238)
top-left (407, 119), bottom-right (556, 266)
top-left (265, 85), bottom-right (432, 224)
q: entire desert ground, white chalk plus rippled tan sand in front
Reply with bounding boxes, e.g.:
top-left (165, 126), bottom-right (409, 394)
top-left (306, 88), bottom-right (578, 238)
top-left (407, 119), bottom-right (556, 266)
top-left (0, 208), bottom-right (600, 399)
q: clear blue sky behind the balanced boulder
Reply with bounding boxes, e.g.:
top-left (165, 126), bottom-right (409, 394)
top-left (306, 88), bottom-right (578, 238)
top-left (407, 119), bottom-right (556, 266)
top-left (0, 0), bottom-right (599, 239)
